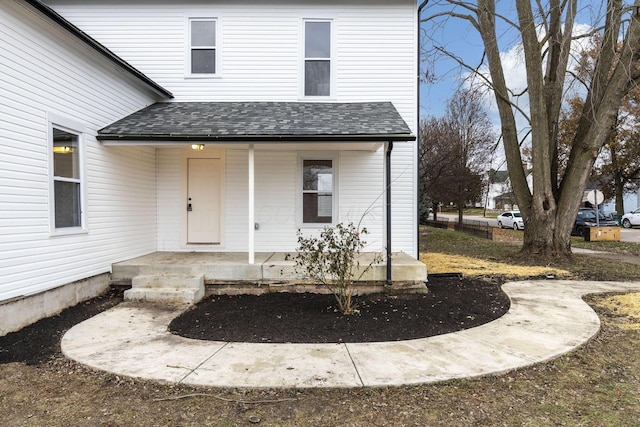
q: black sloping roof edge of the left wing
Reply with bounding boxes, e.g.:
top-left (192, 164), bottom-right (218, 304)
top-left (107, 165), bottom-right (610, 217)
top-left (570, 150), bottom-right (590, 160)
top-left (24, 0), bottom-right (173, 99)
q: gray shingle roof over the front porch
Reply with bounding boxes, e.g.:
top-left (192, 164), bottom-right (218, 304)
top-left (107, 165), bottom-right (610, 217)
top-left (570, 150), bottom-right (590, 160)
top-left (98, 102), bottom-right (415, 142)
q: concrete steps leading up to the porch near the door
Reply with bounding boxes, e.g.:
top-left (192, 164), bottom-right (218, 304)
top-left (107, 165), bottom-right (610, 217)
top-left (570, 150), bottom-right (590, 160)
top-left (124, 274), bottom-right (204, 304)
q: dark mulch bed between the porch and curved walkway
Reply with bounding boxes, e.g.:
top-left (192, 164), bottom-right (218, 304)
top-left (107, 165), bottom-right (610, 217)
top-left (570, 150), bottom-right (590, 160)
top-left (169, 277), bottom-right (509, 343)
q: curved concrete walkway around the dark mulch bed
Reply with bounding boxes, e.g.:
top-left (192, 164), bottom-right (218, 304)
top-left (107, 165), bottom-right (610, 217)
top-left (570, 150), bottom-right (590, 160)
top-left (62, 280), bottom-right (640, 388)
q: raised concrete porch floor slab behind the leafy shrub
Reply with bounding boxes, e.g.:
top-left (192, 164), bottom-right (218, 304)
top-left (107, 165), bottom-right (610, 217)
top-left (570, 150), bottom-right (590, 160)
top-left (111, 252), bottom-right (427, 295)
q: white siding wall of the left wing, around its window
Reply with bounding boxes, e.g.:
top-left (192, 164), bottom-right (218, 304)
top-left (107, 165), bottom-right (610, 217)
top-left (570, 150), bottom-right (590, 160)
top-left (0, 2), bottom-right (160, 301)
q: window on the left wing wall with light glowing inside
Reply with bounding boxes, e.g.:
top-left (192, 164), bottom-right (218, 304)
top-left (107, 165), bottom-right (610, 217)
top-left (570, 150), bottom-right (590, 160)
top-left (52, 126), bottom-right (83, 230)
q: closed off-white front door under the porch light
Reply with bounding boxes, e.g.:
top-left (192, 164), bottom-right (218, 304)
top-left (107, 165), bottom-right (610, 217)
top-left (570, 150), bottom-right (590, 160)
top-left (187, 158), bottom-right (222, 243)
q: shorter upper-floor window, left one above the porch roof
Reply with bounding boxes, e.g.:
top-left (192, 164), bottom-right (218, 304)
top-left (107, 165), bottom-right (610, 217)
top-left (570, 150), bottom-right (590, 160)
top-left (189, 18), bottom-right (218, 76)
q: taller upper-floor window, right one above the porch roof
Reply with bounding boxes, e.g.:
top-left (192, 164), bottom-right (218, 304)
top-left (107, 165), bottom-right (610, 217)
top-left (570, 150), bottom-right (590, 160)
top-left (304, 20), bottom-right (331, 96)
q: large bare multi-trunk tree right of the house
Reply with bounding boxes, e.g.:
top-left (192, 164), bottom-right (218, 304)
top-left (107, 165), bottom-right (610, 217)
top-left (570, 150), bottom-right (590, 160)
top-left (424, 0), bottom-right (640, 258)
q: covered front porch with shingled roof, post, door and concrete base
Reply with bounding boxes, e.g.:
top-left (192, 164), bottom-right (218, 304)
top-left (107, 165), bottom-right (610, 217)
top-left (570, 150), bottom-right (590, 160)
top-left (98, 102), bottom-right (427, 302)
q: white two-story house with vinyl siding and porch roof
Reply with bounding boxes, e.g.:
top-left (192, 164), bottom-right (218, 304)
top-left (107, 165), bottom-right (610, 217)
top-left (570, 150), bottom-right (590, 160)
top-left (0, 0), bottom-right (418, 334)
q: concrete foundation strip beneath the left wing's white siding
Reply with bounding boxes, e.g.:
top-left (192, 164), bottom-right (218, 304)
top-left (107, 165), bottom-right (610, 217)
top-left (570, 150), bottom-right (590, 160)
top-left (0, 274), bottom-right (109, 336)
